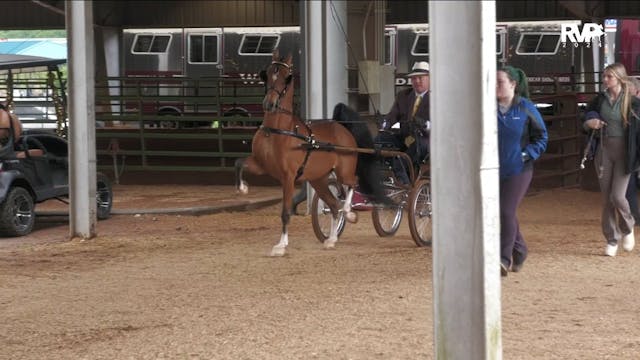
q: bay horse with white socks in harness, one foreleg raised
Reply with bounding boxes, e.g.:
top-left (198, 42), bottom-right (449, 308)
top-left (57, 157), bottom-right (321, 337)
top-left (235, 50), bottom-right (376, 256)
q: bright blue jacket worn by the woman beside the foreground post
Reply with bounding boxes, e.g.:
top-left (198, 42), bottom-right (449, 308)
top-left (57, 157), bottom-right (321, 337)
top-left (498, 96), bottom-right (548, 180)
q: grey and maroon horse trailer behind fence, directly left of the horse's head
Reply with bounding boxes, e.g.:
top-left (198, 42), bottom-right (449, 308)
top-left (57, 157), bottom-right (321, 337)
top-left (122, 27), bottom-right (300, 116)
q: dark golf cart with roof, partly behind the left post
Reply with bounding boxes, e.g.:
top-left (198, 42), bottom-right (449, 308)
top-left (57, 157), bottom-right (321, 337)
top-left (0, 55), bottom-right (113, 236)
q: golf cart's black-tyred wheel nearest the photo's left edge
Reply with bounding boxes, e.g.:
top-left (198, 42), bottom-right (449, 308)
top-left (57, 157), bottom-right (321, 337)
top-left (0, 187), bottom-right (36, 236)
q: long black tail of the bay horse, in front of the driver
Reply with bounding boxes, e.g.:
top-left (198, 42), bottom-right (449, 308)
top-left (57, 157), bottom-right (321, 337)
top-left (333, 103), bottom-right (391, 204)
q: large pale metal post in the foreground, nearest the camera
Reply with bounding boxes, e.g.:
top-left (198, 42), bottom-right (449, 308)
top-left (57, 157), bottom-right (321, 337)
top-left (425, 1), bottom-right (502, 359)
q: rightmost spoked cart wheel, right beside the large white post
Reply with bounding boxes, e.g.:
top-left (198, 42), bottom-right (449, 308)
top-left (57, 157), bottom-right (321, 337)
top-left (409, 180), bottom-right (433, 246)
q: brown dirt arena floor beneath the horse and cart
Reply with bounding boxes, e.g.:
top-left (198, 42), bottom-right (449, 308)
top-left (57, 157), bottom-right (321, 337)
top-left (0, 187), bottom-right (640, 360)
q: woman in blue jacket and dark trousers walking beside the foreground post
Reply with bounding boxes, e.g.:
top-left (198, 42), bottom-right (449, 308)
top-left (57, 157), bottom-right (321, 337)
top-left (496, 66), bottom-right (548, 276)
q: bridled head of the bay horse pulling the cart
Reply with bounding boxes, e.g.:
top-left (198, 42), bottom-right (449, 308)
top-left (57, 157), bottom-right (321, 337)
top-left (260, 50), bottom-right (293, 112)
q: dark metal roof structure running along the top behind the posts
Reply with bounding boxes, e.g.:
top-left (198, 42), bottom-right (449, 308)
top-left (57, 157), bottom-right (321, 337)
top-left (0, 0), bottom-right (640, 29)
